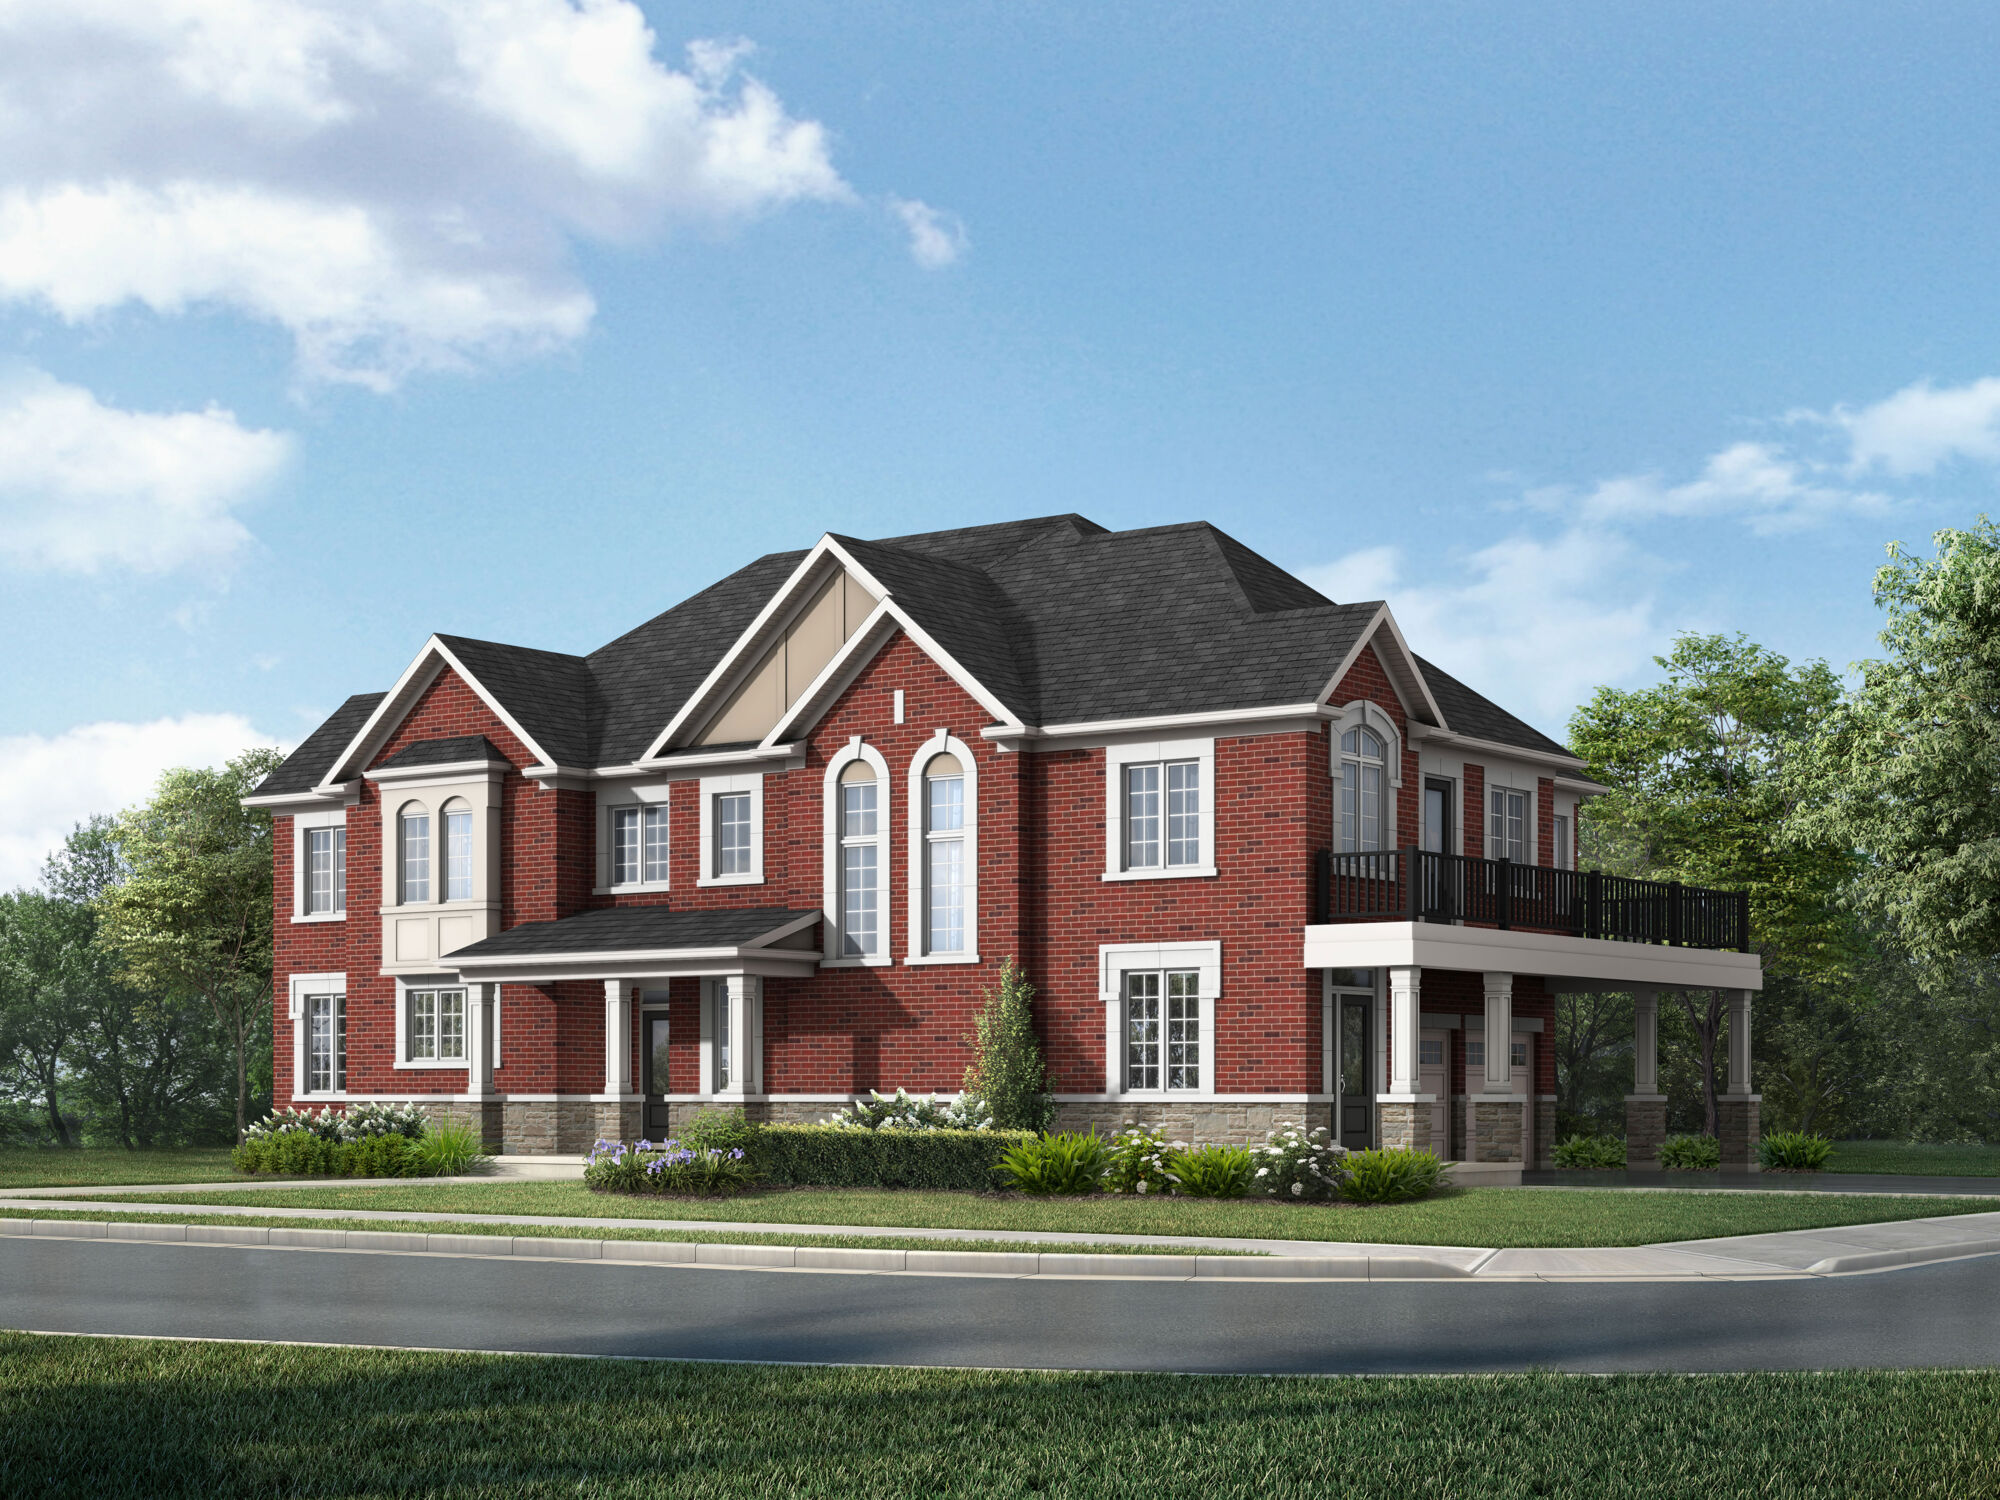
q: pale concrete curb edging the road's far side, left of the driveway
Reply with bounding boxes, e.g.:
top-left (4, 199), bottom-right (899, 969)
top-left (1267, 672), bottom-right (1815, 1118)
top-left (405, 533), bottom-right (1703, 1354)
top-left (0, 1218), bottom-right (1470, 1282)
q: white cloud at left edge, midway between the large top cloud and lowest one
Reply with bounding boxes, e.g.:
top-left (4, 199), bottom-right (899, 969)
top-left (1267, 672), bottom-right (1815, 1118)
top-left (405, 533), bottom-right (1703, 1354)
top-left (0, 368), bottom-right (292, 574)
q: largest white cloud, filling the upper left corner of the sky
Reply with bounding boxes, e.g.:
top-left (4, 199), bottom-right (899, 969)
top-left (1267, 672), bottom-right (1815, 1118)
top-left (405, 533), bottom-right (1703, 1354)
top-left (0, 0), bottom-right (854, 388)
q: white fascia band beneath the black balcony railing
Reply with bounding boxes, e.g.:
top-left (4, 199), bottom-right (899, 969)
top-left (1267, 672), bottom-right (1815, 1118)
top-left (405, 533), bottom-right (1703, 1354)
top-left (1304, 922), bottom-right (1764, 990)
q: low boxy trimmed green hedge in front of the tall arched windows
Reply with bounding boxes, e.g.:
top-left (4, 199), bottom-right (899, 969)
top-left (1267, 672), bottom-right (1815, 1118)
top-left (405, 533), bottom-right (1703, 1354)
top-left (750, 1126), bottom-right (1034, 1192)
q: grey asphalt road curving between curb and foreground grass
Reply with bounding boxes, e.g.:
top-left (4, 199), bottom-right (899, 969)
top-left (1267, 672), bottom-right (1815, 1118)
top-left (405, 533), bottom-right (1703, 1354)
top-left (0, 1238), bottom-right (2000, 1374)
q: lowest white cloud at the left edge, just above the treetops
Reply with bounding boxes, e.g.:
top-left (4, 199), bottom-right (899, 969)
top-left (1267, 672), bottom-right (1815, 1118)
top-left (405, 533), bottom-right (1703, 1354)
top-left (0, 714), bottom-right (276, 890)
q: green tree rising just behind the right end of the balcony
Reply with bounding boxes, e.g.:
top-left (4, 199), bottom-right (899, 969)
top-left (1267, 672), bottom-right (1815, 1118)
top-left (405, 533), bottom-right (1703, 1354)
top-left (1570, 634), bottom-right (1854, 1130)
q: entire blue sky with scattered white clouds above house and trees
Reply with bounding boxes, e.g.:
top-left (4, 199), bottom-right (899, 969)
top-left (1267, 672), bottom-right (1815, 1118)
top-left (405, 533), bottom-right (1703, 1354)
top-left (0, 0), bottom-right (2000, 886)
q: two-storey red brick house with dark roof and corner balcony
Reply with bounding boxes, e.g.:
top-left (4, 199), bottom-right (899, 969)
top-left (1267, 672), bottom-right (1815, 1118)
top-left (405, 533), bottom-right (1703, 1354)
top-left (250, 516), bottom-right (1760, 1174)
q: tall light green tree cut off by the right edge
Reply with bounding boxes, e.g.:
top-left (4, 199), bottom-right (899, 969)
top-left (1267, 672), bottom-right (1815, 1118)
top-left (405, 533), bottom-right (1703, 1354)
top-left (1792, 516), bottom-right (2000, 982)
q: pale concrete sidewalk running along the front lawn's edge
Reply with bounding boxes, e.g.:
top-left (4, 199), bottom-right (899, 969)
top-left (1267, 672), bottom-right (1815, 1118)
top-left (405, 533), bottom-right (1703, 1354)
top-left (0, 1196), bottom-right (2000, 1282)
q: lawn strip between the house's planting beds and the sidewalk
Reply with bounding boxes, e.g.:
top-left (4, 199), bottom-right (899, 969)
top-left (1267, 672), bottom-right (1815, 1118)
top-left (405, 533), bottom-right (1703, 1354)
top-left (66, 1182), bottom-right (1996, 1248)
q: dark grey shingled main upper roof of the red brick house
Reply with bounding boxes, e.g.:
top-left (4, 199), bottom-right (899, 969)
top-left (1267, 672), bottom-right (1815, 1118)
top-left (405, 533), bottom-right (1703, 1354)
top-left (258, 516), bottom-right (1568, 792)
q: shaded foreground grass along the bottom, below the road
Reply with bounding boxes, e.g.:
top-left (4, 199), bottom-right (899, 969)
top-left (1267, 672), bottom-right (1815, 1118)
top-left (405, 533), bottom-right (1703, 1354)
top-left (0, 1334), bottom-right (2000, 1500)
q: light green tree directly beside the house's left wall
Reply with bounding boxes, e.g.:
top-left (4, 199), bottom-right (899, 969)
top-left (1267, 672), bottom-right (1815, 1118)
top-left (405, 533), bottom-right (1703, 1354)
top-left (104, 750), bottom-right (282, 1140)
